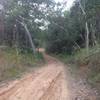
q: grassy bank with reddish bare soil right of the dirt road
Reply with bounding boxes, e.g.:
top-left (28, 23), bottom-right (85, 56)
top-left (56, 46), bottom-right (100, 90)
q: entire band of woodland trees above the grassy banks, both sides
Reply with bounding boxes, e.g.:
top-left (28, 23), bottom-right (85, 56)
top-left (0, 0), bottom-right (100, 54)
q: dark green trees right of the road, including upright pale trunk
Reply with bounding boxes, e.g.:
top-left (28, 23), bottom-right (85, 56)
top-left (47, 0), bottom-right (100, 53)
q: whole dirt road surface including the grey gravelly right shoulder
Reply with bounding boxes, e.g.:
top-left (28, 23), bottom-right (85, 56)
top-left (0, 54), bottom-right (100, 100)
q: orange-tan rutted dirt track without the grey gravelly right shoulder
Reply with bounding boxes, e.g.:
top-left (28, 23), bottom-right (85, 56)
top-left (0, 55), bottom-right (70, 100)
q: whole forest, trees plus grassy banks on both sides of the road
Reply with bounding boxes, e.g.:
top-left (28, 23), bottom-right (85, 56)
top-left (0, 0), bottom-right (100, 100)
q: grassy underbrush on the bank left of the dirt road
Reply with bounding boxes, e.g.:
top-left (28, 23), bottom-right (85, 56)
top-left (0, 48), bottom-right (44, 82)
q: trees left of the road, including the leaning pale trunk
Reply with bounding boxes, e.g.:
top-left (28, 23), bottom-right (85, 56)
top-left (0, 0), bottom-right (54, 52)
